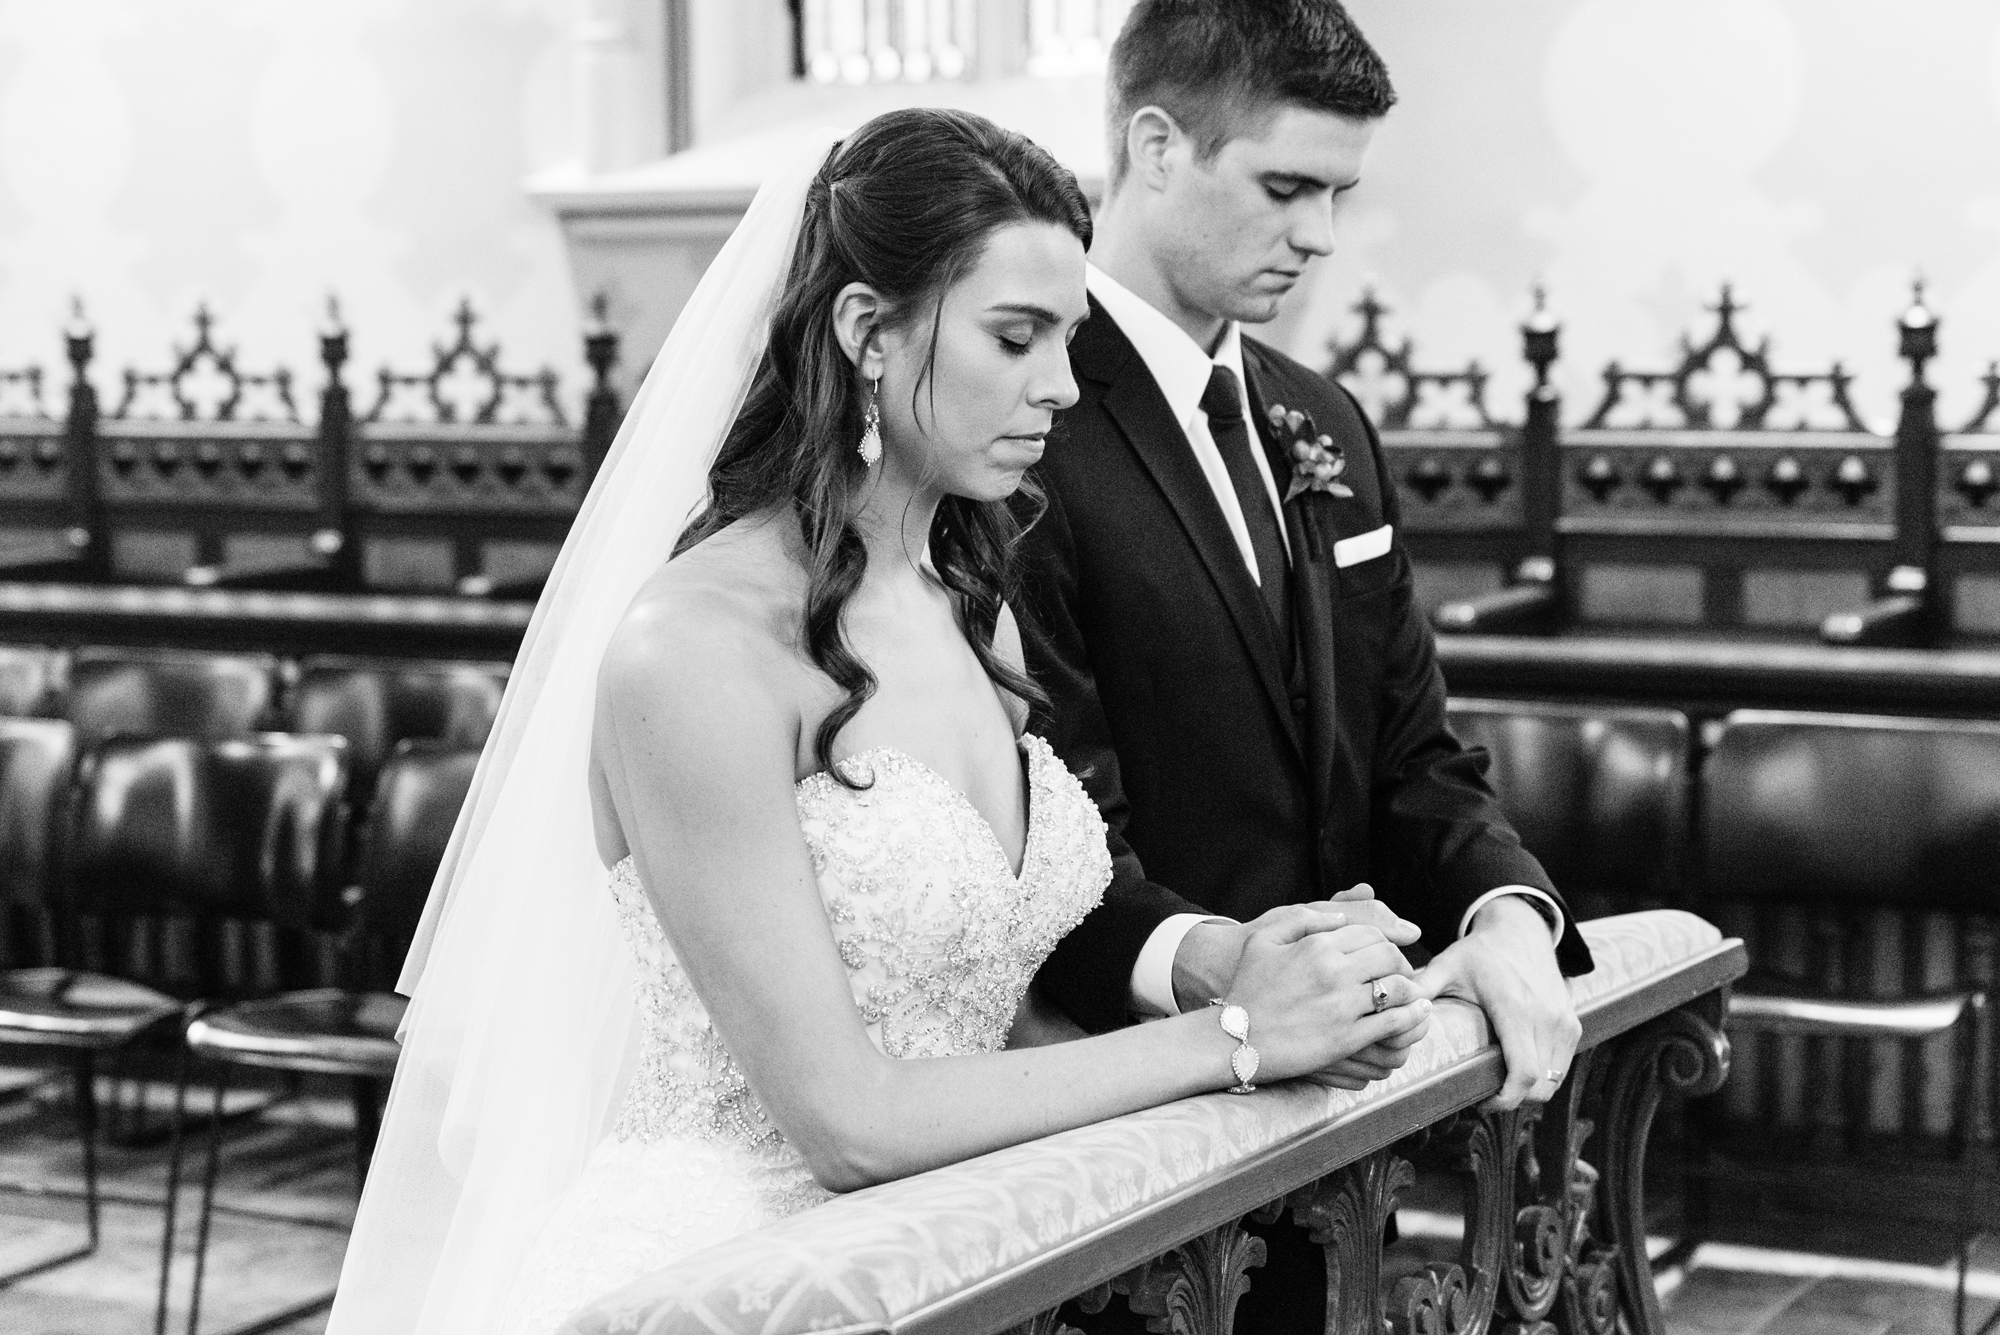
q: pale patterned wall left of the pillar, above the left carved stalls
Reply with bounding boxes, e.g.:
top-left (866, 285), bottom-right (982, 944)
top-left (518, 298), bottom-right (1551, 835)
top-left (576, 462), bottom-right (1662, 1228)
top-left (0, 0), bottom-right (582, 417)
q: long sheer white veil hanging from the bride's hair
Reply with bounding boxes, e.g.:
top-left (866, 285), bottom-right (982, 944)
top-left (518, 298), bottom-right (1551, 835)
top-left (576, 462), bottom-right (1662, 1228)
top-left (328, 127), bottom-right (832, 1335)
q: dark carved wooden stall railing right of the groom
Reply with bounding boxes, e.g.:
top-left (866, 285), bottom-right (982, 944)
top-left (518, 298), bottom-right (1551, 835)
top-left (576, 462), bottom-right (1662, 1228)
top-left (1326, 286), bottom-right (2000, 655)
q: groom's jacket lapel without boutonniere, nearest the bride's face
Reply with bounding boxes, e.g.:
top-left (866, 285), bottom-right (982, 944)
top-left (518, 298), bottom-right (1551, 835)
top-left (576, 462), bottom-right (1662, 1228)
top-left (1070, 300), bottom-right (1298, 745)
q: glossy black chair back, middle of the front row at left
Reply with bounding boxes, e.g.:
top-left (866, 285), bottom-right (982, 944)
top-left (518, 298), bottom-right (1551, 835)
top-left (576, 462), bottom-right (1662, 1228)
top-left (66, 733), bottom-right (346, 929)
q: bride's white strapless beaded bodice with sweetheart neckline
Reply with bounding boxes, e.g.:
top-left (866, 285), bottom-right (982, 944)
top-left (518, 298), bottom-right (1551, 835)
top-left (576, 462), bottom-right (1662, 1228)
top-left (612, 735), bottom-right (1110, 1149)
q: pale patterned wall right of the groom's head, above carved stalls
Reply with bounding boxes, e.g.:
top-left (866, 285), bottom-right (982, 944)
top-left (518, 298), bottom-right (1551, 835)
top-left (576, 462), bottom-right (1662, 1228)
top-left (1288, 0), bottom-right (2000, 422)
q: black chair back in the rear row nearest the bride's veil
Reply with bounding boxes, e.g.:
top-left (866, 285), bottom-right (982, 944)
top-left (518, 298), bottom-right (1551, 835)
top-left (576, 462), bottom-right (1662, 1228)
top-left (290, 658), bottom-right (506, 799)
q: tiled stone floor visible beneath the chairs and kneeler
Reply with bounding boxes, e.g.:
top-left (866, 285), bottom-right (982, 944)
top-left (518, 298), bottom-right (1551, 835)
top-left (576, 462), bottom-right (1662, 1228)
top-left (0, 1079), bottom-right (2000, 1335)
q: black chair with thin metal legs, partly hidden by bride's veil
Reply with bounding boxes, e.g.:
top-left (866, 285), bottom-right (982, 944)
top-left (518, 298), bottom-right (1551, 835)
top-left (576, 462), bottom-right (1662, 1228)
top-left (156, 741), bottom-right (480, 1335)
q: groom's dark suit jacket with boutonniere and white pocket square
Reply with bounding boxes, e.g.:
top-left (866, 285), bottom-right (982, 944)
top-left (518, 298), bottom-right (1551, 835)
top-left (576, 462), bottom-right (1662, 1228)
top-left (1020, 300), bottom-right (1590, 1031)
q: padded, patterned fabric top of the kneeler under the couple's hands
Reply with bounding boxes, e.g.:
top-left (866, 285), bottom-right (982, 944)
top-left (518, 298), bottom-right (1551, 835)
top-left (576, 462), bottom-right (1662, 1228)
top-left (562, 909), bottom-right (1744, 1335)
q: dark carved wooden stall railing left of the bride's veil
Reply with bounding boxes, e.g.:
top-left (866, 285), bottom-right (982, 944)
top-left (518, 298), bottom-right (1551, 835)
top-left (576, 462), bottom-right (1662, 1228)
top-left (0, 300), bottom-right (620, 598)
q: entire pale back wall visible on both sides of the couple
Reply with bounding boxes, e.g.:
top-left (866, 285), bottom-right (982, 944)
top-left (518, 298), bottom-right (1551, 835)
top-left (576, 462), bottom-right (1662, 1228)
top-left (0, 0), bottom-right (2000, 427)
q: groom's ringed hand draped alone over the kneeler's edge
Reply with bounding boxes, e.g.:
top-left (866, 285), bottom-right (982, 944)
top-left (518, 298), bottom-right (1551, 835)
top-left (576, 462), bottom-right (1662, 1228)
top-left (1416, 895), bottom-right (1584, 1111)
